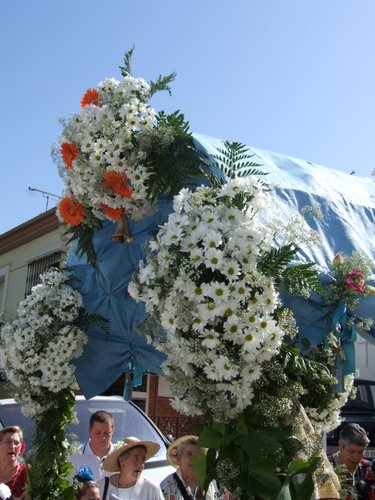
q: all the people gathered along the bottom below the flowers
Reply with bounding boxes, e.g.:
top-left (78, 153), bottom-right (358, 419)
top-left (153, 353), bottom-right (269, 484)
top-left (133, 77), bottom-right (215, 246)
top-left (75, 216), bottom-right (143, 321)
top-left (0, 411), bottom-right (375, 500)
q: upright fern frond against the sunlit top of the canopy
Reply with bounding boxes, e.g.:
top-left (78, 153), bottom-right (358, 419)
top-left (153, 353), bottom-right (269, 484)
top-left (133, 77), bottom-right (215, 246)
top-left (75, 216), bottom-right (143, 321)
top-left (213, 141), bottom-right (267, 179)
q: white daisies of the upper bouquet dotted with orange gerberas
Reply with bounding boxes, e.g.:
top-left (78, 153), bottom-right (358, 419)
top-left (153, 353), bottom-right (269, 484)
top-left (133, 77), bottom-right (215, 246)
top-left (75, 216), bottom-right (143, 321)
top-left (60, 75), bottom-right (159, 220)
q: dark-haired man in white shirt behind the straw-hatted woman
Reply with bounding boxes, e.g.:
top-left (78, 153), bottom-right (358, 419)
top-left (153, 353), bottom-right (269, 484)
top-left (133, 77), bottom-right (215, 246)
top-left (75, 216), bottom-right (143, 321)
top-left (68, 410), bottom-right (114, 482)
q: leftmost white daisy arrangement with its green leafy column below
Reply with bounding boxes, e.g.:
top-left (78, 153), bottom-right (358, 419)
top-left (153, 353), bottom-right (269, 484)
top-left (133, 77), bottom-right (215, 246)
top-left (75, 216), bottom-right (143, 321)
top-left (0, 269), bottom-right (102, 500)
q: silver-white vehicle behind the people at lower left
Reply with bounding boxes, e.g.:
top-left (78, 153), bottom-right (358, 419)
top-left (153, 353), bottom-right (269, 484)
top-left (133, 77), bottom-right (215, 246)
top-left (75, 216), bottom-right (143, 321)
top-left (0, 396), bottom-right (175, 483)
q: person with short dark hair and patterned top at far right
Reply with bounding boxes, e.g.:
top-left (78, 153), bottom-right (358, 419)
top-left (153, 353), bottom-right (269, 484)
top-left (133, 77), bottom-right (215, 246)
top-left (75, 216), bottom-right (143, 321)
top-left (328, 424), bottom-right (374, 499)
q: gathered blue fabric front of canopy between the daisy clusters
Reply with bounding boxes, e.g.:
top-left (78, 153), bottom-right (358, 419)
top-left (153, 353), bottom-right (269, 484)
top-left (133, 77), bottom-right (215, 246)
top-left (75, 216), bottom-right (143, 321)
top-left (67, 193), bottom-right (172, 398)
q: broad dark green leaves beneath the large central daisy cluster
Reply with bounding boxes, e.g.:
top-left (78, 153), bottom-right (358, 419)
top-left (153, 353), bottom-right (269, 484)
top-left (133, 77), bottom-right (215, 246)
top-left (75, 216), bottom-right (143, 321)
top-left (193, 407), bottom-right (317, 500)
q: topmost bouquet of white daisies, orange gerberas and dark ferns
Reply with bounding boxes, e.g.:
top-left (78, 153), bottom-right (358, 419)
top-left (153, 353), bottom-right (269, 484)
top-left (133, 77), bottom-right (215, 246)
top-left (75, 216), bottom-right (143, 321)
top-left (53, 50), bottom-right (216, 266)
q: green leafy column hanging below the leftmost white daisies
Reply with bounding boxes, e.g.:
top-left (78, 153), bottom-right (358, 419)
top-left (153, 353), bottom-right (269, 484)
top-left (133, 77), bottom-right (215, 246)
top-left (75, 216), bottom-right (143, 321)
top-left (28, 389), bottom-right (75, 500)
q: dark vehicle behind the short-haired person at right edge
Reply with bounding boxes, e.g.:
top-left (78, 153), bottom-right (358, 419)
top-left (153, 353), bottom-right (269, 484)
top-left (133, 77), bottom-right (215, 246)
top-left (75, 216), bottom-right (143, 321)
top-left (327, 378), bottom-right (375, 459)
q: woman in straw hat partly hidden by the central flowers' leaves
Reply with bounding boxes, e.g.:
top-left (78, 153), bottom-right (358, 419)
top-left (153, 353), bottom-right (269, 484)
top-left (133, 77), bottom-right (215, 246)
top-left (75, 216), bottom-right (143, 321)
top-left (160, 435), bottom-right (217, 500)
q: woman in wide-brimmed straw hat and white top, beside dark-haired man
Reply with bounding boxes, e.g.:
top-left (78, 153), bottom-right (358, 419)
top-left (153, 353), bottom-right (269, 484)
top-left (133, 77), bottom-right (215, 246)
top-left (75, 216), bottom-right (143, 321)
top-left (100, 437), bottom-right (164, 500)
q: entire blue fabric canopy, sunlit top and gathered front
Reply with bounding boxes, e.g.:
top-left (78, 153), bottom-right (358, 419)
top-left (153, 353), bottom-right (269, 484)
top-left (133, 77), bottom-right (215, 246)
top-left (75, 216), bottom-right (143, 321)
top-left (67, 134), bottom-right (375, 398)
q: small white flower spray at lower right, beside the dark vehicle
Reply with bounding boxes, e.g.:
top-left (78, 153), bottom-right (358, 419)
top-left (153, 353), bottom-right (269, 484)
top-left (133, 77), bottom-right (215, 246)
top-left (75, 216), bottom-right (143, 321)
top-left (305, 373), bottom-right (355, 434)
